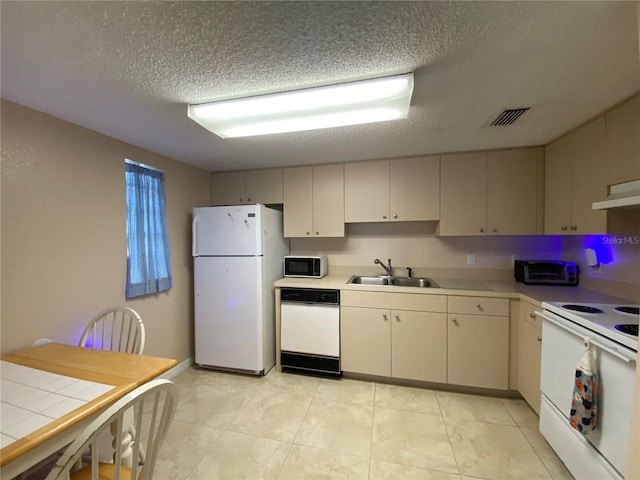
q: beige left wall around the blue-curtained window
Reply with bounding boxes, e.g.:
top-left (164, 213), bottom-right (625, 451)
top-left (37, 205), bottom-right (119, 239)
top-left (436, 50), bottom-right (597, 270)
top-left (1, 101), bottom-right (209, 361)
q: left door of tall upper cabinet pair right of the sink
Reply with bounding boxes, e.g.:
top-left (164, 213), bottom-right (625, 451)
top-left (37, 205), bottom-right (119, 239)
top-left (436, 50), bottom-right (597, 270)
top-left (439, 153), bottom-right (487, 235)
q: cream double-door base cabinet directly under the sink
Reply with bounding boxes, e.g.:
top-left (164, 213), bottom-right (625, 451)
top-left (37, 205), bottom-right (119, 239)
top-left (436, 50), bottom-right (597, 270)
top-left (340, 291), bottom-right (447, 383)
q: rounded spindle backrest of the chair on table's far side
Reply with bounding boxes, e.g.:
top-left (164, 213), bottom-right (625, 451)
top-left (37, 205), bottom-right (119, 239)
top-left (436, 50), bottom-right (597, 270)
top-left (78, 307), bottom-right (145, 354)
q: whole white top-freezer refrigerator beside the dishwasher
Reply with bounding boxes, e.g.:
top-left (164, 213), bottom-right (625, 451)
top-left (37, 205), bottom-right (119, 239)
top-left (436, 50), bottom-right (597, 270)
top-left (192, 204), bottom-right (289, 375)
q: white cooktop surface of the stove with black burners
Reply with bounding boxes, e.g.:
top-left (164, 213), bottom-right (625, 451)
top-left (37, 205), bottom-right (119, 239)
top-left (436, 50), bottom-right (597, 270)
top-left (542, 302), bottom-right (640, 352)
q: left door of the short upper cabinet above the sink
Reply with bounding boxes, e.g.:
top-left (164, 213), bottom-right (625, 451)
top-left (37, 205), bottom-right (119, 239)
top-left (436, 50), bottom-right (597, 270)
top-left (344, 160), bottom-right (389, 223)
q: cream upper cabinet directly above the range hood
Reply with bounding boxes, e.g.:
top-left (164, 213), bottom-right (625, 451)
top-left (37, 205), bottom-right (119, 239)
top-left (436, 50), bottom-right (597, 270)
top-left (605, 95), bottom-right (640, 185)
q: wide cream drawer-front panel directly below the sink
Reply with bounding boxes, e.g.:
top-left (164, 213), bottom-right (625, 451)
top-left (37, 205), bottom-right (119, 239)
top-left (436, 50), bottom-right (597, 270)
top-left (340, 290), bottom-right (447, 312)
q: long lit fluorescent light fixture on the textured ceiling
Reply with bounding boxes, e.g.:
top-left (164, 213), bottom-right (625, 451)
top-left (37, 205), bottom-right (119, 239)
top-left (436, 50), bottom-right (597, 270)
top-left (188, 73), bottom-right (413, 138)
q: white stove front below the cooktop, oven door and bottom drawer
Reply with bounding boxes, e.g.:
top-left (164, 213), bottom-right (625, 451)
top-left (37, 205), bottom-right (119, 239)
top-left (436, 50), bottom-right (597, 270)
top-left (540, 310), bottom-right (637, 478)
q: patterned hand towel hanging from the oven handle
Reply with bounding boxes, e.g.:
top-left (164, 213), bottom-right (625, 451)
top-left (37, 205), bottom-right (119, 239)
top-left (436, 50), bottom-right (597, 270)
top-left (569, 338), bottom-right (598, 435)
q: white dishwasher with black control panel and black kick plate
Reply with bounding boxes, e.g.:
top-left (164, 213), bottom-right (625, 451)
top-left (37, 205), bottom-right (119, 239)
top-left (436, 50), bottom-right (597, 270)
top-left (280, 288), bottom-right (342, 376)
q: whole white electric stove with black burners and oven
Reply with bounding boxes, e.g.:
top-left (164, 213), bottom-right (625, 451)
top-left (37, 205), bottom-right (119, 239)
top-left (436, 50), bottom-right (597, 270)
top-left (537, 302), bottom-right (640, 480)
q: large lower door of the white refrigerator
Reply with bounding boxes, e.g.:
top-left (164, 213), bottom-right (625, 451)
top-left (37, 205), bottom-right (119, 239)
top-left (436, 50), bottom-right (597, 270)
top-left (194, 257), bottom-right (265, 373)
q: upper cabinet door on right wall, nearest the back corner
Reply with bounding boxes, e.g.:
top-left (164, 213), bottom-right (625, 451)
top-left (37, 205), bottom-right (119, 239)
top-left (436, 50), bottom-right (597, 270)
top-left (544, 137), bottom-right (571, 235)
